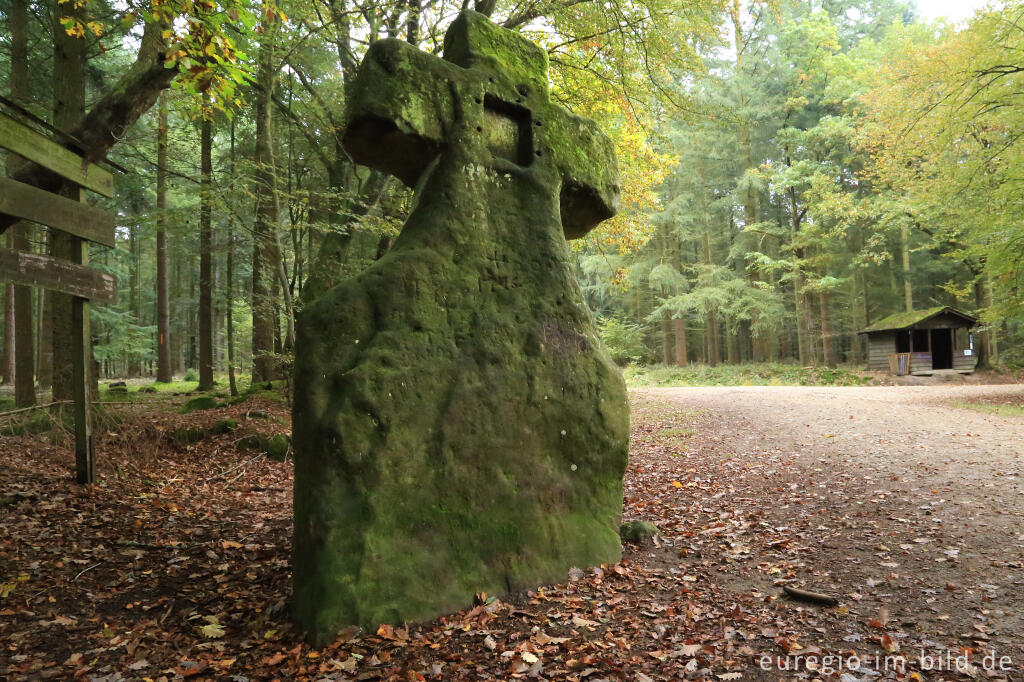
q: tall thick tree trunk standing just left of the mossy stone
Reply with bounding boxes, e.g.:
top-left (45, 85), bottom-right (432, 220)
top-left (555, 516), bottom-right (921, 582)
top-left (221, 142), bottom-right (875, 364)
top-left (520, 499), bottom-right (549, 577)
top-left (252, 13), bottom-right (280, 384)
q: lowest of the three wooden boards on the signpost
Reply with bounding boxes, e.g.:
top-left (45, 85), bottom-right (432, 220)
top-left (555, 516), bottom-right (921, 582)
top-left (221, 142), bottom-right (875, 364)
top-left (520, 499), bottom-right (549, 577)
top-left (0, 249), bottom-right (117, 303)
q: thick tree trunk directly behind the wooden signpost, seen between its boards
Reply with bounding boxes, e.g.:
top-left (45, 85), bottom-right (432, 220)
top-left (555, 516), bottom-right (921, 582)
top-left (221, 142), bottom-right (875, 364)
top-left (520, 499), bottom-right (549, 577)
top-left (49, 0), bottom-right (91, 400)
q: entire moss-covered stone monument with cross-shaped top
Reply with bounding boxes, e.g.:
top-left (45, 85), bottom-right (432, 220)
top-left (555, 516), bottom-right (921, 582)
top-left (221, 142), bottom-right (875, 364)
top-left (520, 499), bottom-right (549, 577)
top-left (293, 12), bottom-right (629, 643)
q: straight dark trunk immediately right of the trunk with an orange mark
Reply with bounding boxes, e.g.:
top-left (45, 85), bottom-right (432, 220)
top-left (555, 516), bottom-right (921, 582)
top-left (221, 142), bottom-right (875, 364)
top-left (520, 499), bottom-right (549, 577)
top-left (199, 98), bottom-right (213, 391)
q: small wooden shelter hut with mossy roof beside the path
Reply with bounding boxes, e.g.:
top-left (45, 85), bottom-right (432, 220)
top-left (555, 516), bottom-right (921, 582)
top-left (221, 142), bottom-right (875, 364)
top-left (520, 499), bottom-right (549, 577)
top-left (859, 305), bottom-right (978, 375)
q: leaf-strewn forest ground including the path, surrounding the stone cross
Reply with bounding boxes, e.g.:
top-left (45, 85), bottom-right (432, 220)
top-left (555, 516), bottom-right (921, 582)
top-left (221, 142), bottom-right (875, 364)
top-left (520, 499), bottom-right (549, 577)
top-left (0, 386), bottom-right (1024, 682)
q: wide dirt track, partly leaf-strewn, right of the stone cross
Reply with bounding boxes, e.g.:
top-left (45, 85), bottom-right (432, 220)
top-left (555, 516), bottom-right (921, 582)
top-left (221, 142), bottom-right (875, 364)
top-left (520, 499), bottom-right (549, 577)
top-left (627, 385), bottom-right (1024, 679)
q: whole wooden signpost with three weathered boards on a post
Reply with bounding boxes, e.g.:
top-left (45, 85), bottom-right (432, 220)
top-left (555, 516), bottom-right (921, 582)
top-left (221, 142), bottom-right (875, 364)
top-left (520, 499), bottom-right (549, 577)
top-left (0, 113), bottom-right (117, 483)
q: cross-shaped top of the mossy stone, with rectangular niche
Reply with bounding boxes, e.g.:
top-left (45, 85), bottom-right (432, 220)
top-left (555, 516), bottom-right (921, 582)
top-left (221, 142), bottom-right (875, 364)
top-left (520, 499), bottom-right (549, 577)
top-left (344, 11), bottom-right (618, 239)
